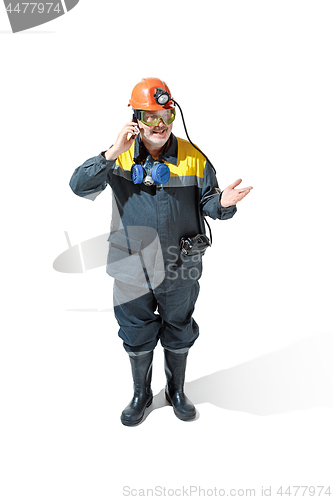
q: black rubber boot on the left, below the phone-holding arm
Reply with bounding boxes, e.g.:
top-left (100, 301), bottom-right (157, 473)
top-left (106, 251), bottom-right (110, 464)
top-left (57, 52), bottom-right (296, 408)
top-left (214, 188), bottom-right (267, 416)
top-left (120, 351), bottom-right (153, 425)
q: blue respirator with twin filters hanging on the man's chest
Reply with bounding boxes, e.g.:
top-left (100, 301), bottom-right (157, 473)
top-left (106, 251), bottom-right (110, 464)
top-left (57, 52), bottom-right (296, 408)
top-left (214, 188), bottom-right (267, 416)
top-left (131, 155), bottom-right (170, 186)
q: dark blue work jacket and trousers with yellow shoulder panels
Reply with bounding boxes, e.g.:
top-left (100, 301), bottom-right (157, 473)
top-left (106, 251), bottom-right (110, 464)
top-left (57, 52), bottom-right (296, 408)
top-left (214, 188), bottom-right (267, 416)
top-left (70, 134), bottom-right (237, 353)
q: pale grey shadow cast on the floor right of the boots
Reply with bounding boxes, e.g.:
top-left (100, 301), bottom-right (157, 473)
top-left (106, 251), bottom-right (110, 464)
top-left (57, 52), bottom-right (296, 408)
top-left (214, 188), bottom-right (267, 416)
top-left (145, 334), bottom-right (333, 418)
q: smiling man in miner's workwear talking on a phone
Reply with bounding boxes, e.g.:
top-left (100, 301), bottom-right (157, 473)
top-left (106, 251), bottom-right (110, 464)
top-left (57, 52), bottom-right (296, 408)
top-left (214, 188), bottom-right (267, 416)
top-left (70, 78), bottom-right (252, 426)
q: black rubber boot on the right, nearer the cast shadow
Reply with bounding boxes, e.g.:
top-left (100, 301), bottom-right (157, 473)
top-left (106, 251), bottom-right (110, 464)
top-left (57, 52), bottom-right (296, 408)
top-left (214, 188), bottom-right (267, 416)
top-left (164, 349), bottom-right (196, 420)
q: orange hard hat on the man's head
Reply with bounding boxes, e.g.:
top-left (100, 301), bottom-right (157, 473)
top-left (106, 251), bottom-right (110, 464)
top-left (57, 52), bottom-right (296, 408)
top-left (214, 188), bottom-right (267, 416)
top-left (128, 78), bottom-right (175, 111)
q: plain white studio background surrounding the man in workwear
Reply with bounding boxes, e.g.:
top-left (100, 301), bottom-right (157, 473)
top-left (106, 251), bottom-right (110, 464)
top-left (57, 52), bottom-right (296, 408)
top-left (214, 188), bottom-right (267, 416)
top-left (0, 0), bottom-right (333, 500)
